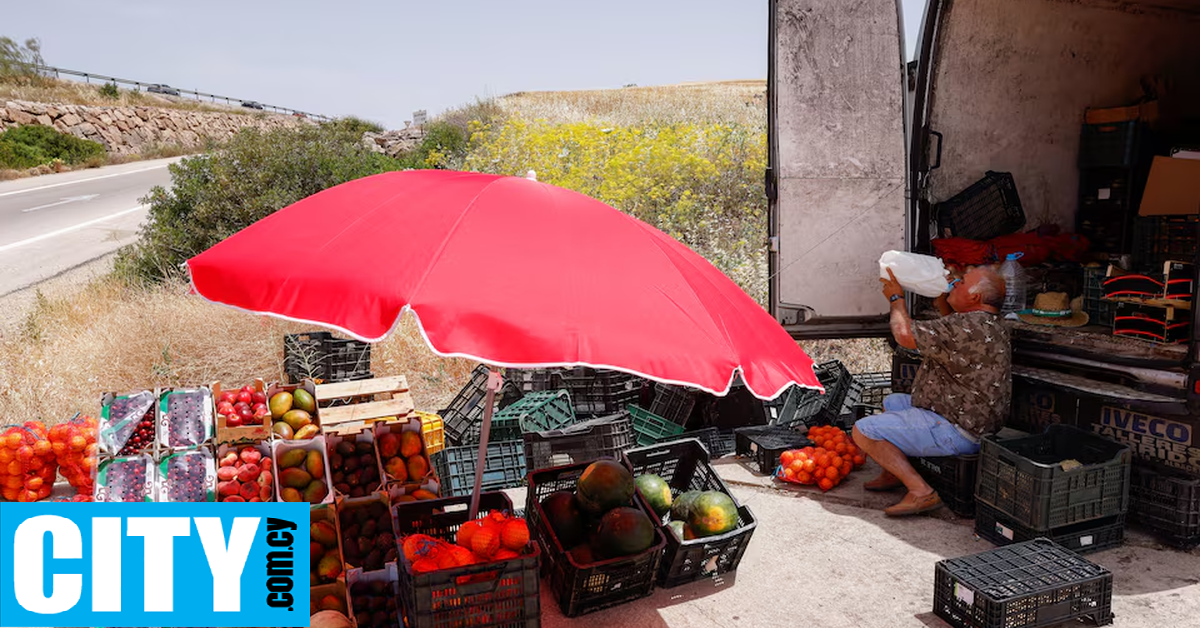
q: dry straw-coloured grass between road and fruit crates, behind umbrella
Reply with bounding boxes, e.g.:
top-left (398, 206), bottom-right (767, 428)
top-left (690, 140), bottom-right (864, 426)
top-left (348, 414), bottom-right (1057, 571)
top-left (0, 279), bottom-right (473, 423)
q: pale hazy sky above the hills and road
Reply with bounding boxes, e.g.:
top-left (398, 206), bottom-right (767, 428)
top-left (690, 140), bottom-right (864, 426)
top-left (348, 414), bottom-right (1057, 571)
top-left (7, 0), bottom-right (924, 128)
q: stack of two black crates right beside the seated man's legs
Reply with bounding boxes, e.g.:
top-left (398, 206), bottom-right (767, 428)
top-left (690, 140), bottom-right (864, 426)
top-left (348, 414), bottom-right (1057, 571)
top-left (976, 425), bottom-right (1133, 552)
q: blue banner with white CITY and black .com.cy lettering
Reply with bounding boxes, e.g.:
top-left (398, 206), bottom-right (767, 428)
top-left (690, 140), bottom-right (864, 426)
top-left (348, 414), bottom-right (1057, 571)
top-left (0, 502), bottom-right (310, 627)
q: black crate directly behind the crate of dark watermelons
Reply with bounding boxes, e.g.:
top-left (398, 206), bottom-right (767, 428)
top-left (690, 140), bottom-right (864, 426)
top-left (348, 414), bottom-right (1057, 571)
top-left (523, 412), bottom-right (634, 471)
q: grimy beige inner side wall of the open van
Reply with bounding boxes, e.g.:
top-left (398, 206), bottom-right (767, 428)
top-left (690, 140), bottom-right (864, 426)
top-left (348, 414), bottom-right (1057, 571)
top-left (929, 0), bottom-right (1200, 231)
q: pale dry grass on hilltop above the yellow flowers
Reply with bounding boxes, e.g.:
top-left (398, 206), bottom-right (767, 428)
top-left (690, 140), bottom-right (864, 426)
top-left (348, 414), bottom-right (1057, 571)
top-left (498, 80), bottom-right (767, 128)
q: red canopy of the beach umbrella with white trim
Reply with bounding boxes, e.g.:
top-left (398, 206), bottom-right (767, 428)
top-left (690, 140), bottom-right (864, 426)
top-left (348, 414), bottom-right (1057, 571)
top-left (187, 171), bottom-right (821, 399)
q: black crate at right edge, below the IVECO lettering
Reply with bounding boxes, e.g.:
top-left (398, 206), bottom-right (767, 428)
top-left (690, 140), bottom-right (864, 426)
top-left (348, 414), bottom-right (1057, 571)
top-left (1129, 465), bottom-right (1200, 549)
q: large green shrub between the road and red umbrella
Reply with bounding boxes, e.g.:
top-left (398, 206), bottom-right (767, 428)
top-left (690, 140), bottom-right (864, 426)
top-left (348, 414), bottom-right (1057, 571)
top-left (116, 124), bottom-right (402, 282)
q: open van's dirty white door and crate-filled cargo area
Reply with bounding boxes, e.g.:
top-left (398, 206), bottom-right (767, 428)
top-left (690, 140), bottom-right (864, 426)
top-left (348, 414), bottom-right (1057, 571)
top-left (767, 0), bottom-right (1200, 478)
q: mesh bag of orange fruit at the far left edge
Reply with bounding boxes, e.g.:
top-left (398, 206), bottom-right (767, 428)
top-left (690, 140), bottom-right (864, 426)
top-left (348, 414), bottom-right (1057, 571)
top-left (0, 420), bottom-right (59, 502)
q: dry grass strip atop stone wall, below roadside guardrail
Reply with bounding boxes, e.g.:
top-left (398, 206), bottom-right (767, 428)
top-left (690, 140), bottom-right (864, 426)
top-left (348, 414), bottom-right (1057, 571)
top-left (0, 78), bottom-right (252, 115)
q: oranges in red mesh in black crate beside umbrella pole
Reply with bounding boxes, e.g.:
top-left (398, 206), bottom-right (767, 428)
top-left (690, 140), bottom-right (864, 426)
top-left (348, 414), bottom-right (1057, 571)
top-left (400, 510), bottom-right (529, 573)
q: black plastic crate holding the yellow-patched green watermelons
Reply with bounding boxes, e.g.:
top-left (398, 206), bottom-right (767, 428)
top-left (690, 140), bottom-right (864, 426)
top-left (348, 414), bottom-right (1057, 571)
top-left (625, 438), bottom-right (756, 588)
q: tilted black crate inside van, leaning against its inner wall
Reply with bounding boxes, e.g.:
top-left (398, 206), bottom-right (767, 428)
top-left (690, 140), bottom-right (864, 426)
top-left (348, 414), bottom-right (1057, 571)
top-left (934, 171), bottom-right (1025, 240)
